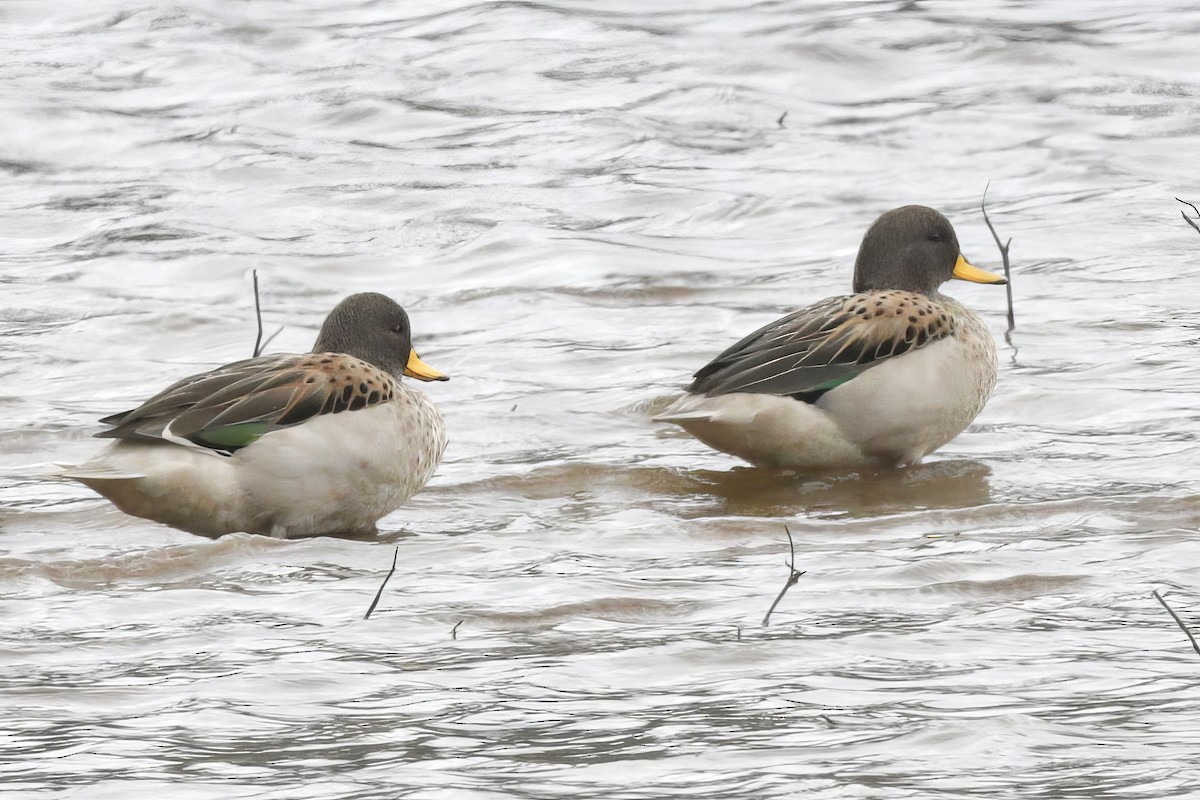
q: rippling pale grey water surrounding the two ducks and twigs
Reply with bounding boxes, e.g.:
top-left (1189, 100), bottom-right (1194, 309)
top-left (0, 0), bottom-right (1200, 800)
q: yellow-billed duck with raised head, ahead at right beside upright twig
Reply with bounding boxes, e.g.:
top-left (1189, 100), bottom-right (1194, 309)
top-left (654, 205), bottom-right (1007, 473)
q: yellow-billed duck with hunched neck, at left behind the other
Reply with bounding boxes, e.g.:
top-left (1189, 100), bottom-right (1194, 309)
top-left (62, 291), bottom-right (449, 539)
